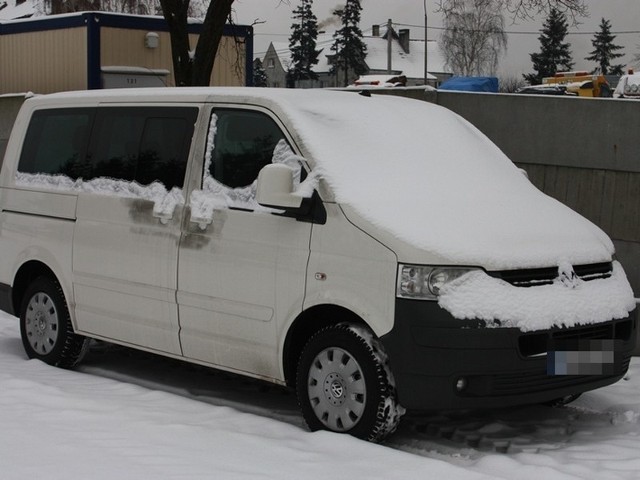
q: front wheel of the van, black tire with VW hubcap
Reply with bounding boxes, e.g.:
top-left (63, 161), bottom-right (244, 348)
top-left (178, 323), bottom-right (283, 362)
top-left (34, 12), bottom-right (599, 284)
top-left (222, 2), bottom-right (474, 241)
top-left (296, 323), bottom-right (404, 442)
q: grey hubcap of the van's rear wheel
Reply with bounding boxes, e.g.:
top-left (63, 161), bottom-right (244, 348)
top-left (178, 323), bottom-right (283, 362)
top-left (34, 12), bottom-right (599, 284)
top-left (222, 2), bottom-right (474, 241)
top-left (25, 292), bottom-right (58, 355)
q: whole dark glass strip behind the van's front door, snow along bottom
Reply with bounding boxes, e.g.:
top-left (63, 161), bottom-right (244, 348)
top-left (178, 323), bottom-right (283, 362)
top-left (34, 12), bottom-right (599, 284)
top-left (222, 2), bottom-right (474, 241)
top-left (18, 107), bottom-right (198, 190)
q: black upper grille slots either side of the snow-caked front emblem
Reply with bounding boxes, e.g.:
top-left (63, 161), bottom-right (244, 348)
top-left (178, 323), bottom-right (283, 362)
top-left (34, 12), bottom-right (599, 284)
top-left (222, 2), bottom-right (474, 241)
top-left (488, 262), bottom-right (613, 287)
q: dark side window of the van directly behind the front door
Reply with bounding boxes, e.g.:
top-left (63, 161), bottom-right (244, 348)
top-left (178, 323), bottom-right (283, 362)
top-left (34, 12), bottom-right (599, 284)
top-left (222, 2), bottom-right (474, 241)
top-left (84, 107), bottom-right (198, 190)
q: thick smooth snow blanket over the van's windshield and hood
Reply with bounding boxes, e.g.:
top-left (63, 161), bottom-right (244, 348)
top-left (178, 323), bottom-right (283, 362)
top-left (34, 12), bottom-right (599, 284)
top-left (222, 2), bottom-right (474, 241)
top-left (276, 92), bottom-right (614, 269)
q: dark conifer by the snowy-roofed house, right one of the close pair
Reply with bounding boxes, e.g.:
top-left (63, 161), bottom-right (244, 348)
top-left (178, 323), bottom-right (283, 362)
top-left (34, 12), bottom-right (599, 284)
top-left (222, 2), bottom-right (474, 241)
top-left (331, 0), bottom-right (367, 87)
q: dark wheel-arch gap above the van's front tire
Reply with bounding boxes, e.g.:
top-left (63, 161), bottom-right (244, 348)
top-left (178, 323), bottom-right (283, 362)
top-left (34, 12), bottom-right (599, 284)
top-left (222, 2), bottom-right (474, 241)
top-left (282, 304), bottom-right (370, 387)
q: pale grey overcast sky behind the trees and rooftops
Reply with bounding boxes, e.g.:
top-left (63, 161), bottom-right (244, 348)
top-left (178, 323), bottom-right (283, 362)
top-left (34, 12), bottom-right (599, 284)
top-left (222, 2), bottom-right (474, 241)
top-left (234, 0), bottom-right (640, 75)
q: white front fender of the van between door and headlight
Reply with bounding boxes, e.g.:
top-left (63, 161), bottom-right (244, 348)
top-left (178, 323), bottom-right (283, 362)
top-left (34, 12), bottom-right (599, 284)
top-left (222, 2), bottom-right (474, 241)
top-left (302, 203), bottom-right (397, 338)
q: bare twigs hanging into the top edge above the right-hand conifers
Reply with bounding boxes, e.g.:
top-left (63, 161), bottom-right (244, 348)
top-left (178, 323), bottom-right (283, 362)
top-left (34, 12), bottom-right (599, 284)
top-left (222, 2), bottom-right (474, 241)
top-left (438, 0), bottom-right (589, 23)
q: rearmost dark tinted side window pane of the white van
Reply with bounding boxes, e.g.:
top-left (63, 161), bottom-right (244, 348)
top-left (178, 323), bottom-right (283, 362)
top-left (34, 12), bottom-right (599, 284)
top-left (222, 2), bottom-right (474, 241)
top-left (18, 108), bottom-right (95, 179)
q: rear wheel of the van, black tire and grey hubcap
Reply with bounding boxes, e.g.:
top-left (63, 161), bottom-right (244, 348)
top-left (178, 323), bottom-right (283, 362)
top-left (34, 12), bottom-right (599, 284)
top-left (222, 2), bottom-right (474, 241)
top-left (20, 277), bottom-right (89, 368)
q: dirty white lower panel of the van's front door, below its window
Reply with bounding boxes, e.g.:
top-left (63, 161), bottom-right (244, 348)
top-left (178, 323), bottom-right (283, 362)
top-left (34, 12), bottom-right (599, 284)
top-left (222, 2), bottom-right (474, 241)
top-left (178, 209), bottom-right (311, 379)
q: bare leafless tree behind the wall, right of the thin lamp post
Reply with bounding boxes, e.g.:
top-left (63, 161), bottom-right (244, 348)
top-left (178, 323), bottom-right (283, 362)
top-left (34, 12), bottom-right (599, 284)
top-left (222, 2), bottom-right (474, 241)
top-left (440, 0), bottom-right (507, 75)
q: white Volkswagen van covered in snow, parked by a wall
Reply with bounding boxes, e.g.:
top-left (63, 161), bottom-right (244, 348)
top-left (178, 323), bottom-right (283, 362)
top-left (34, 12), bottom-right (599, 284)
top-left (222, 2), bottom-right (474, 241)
top-left (0, 88), bottom-right (637, 441)
